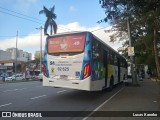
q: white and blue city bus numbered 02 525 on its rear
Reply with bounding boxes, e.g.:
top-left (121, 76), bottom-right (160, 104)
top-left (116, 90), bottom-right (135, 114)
top-left (43, 31), bottom-right (127, 91)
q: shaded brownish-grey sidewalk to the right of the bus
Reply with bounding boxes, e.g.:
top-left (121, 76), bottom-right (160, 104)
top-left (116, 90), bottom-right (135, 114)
top-left (87, 79), bottom-right (160, 120)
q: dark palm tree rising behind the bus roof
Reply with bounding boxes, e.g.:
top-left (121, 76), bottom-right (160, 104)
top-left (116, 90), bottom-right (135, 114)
top-left (39, 6), bottom-right (57, 35)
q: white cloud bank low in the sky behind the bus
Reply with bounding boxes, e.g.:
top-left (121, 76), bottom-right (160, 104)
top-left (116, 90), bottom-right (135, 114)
top-left (0, 22), bottom-right (121, 58)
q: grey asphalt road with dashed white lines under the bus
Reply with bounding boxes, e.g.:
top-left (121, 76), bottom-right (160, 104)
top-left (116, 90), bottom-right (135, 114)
top-left (0, 81), bottom-right (124, 120)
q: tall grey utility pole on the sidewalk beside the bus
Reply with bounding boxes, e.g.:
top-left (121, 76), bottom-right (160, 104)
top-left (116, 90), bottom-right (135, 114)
top-left (126, 5), bottom-right (138, 85)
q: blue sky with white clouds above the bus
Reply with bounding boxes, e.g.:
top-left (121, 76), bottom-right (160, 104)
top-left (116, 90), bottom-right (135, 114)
top-left (0, 0), bottom-right (121, 58)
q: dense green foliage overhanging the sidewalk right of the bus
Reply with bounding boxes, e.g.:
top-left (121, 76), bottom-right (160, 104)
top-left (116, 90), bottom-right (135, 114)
top-left (98, 0), bottom-right (160, 70)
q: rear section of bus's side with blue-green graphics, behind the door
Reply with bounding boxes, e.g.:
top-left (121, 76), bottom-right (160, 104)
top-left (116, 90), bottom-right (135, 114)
top-left (91, 38), bottom-right (107, 91)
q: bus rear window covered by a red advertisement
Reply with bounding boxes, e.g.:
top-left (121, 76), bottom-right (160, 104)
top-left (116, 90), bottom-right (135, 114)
top-left (48, 34), bottom-right (85, 53)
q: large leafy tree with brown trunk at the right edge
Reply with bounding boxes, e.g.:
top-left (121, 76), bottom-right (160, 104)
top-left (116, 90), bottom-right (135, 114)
top-left (99, 0), bottom-right (160, 77)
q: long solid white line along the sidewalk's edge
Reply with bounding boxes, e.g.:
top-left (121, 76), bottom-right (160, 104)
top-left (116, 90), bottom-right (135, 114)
top-left (82, 87), bottom-right (124, 120)
